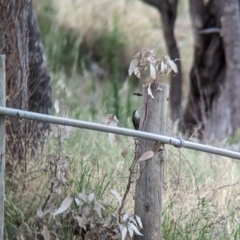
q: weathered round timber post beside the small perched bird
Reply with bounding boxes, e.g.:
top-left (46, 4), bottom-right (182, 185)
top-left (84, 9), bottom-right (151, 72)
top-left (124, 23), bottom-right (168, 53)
top-left (135, 83), bottom-right (169, 240)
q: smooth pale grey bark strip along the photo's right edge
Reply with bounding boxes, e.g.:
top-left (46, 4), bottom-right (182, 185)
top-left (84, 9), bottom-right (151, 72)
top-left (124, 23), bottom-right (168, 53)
top-left (220, 0), bottom-right (240, 133)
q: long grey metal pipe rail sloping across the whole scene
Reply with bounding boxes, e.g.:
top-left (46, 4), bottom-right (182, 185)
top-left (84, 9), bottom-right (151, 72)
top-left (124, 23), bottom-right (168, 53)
top-left (0, 107), bottom-right (240, 160)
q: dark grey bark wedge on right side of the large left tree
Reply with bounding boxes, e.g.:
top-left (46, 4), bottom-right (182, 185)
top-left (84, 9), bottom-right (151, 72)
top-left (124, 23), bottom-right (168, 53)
top-left (28, 0), bottom-right (52, 133)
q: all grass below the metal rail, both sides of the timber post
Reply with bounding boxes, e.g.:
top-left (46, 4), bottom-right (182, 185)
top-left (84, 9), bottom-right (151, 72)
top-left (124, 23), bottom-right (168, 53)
top-left (5, 125), bottom-right (240, 239)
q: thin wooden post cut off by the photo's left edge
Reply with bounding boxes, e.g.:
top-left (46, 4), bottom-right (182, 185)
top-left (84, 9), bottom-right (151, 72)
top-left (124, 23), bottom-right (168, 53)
top-left (0, 55), bottom-right (6, 240)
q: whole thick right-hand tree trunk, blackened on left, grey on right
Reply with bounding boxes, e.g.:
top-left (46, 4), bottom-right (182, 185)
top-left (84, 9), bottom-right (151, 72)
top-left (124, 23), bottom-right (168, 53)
top-left (184, 0), bottom-right (240, 139)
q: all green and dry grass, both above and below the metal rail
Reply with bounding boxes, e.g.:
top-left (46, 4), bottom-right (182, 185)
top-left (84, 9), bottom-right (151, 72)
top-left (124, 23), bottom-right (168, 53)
top-left (5, 0), bottom-right (240, 240)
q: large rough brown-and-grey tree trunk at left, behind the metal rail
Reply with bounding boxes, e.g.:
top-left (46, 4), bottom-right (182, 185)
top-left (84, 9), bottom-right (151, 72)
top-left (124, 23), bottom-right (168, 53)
top-left (0, 0), bottom-right (51, 171)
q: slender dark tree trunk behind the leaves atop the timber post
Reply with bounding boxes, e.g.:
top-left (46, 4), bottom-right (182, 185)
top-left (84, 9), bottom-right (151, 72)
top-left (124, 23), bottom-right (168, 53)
top-left (141, 0), bottom-right (182, 122)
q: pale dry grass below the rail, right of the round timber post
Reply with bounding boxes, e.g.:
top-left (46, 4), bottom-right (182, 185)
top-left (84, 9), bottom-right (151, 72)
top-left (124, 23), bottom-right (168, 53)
top-left (163, 146), bottom-right (240, 239)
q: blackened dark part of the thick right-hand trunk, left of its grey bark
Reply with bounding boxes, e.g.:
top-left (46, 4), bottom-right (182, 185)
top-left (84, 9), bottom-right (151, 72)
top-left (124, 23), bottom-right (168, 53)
top-left (184, 0), bottom-right (227, 138)
